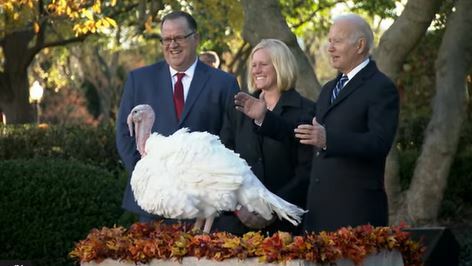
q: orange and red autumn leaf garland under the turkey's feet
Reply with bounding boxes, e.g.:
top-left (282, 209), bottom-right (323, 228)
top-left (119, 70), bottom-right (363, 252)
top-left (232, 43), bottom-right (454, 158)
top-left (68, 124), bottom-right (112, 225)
top-left (69, 222), bottom-right (425, 265)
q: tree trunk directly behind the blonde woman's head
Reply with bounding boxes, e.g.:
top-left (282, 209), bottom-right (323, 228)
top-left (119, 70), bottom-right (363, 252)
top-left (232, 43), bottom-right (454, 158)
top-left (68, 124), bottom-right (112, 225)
top-left (241, 0), bottom-right (321, 100)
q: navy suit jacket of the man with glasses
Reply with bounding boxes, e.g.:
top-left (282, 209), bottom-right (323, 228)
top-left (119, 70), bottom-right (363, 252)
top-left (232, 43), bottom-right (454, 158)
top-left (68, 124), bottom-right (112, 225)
top-left (116, 61), bottom-right (239, 215)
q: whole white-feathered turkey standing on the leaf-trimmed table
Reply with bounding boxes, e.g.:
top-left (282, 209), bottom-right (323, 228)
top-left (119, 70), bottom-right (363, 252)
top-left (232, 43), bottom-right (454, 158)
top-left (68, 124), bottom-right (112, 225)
top-left (128, 105), bottom-right (305, 233)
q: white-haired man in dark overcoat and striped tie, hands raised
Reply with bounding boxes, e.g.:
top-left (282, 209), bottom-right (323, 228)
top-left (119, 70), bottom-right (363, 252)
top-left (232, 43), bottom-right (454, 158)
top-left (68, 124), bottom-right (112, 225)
top-left (295, 14), bottom-right (399, 232)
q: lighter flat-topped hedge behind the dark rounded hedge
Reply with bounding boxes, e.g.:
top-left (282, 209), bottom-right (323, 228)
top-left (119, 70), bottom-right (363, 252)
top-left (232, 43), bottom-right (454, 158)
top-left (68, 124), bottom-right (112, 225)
top-left (0, 124), bottom-right (123, 171)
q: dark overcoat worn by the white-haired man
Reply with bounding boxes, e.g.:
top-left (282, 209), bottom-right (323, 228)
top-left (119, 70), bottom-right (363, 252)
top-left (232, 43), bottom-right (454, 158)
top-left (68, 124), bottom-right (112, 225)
top-left (304, 60), bottom-right (399, 232)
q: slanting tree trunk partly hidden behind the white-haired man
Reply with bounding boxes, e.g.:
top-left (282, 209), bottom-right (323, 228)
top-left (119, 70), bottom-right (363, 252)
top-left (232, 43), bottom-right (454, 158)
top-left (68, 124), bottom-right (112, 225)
top-left (374, 0), bottom-right (442, 224)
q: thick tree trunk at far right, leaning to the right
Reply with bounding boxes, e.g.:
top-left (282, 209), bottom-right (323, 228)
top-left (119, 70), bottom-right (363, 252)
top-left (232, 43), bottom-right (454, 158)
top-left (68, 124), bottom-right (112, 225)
top-left (396, 0), bottom-right (472, 226)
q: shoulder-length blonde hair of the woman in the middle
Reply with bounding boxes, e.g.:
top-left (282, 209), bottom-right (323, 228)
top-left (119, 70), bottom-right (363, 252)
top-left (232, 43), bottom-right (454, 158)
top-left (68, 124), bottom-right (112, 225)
top-left (247, 39), bottom-right (298, 93)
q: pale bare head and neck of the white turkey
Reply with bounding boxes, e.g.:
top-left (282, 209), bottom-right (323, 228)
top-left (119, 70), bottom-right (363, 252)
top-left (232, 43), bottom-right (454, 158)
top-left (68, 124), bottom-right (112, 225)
top-left (127, 104), bottom-right (155, 156)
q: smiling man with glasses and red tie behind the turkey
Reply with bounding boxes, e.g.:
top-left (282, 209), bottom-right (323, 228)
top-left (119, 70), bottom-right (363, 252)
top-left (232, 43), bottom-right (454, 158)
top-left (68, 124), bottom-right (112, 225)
top-left (116, 11), bottom-right (239, 222)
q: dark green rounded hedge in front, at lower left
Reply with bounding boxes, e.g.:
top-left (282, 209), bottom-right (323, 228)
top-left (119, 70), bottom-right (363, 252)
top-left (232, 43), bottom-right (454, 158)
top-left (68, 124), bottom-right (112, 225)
top-left (0, 158), bottom-right (125, 265)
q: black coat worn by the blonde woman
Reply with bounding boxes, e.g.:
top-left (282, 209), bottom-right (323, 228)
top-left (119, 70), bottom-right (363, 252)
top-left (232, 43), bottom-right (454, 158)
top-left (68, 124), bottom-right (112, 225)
top-left (213, 89), bottom-right (314, 235)
